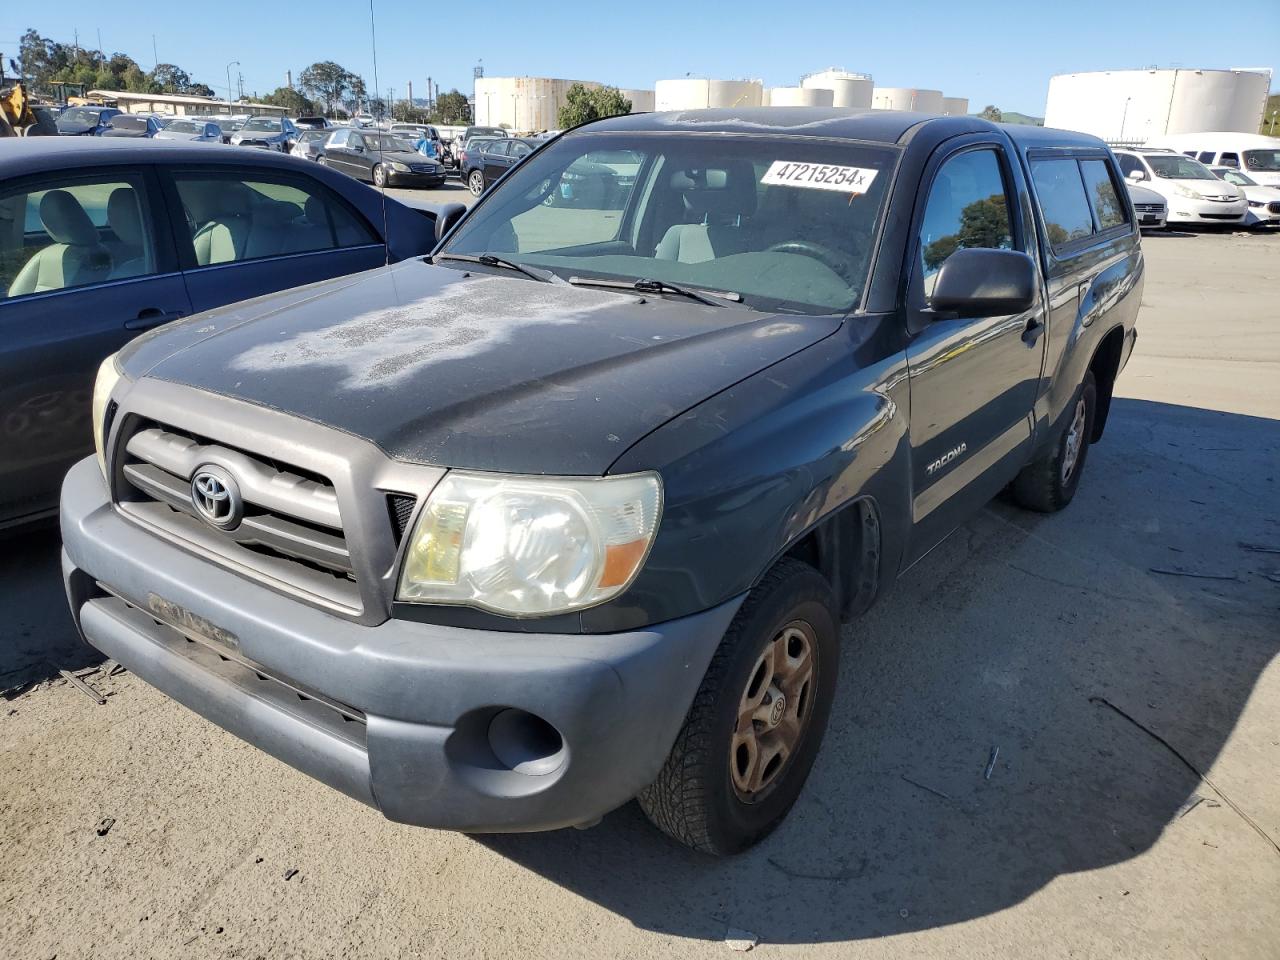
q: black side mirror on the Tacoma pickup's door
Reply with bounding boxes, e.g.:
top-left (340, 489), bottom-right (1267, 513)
top-left (929, 248), bottom-right (1037, 317)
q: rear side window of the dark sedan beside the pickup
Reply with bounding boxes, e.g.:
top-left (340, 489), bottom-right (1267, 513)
top-left (174, 170), bottom-right (380, 266)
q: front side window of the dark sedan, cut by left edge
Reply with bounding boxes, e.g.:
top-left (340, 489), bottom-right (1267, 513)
top-left (0, 173), bottom-right (156, 298)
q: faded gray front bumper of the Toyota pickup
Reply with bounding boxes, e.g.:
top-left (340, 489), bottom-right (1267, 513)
top-left (61, 458), bottom-right (742, 832)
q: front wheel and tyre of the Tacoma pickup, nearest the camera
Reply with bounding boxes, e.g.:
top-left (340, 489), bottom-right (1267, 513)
top-left (639, 558), bottom-right (840, 856)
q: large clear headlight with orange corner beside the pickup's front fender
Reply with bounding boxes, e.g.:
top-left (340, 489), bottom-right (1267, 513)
top-left (397, 472), bottom-right (662, 617)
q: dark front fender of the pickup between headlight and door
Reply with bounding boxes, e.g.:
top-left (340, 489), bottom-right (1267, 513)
top-left (599, 316), bottom-right (911, 630)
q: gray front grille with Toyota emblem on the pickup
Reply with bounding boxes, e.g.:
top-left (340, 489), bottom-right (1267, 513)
top-left (116, 420), bottom-right (361, 613)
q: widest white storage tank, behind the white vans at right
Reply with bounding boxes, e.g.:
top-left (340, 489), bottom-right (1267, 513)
top-left (1044, 68), bottom-right (1271, 145)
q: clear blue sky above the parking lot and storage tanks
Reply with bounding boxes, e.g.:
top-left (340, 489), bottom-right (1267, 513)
top-left (0, 0), bottom-right (1280, 115)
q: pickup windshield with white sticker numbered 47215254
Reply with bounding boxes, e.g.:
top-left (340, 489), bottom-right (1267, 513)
top-left (445, 133), bottom-right (897, 314)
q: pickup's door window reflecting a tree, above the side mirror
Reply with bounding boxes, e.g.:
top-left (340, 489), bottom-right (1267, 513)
top-left (920, 150), bottom-right (1014, 296)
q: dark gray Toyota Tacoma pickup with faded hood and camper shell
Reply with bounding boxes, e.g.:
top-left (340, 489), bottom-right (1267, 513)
top-left (61, 108), bottom-right (1143, 854)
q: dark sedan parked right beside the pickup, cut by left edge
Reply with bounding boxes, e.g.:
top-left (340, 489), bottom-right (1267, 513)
top-left (0, 137), bottom-right (461, 527)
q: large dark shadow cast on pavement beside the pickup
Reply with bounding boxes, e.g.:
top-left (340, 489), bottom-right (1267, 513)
top-left (477, 399), bottom-right (1280, 943)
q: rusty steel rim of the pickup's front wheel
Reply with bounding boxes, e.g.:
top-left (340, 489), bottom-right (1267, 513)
top-left (728, 620), bottom-right (818, 803)
